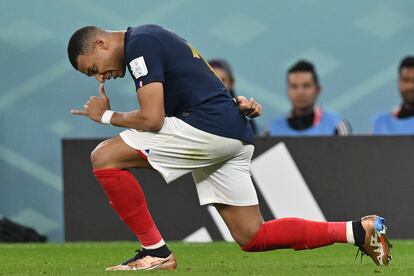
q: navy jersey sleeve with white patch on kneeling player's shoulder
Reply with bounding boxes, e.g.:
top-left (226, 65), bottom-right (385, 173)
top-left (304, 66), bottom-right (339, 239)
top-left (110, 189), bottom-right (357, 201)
top-left (125, 34), bottom-right (164, 89)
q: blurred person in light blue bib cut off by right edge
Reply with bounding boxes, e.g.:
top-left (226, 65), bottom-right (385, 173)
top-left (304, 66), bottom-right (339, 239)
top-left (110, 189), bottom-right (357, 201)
top-left (372, 56), bottom-right (414, 135)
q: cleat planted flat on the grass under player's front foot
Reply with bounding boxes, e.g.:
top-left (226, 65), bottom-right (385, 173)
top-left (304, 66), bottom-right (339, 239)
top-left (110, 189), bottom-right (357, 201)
top-left (106, 250), bottom-right (177, 271)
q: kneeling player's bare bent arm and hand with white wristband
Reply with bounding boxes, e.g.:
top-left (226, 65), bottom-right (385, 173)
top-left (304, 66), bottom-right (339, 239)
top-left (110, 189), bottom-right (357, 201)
top-left (71, 82), bottom-right (165, 131)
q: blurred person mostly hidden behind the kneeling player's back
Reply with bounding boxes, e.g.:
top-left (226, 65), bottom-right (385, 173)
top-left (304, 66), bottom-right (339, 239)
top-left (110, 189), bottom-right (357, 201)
top-left (208, 59), bottom-right (257, 135)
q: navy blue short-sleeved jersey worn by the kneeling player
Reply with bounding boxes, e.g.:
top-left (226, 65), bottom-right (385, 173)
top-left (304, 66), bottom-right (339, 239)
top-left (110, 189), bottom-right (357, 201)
top-left (125, 25), bottom-right (253, 144)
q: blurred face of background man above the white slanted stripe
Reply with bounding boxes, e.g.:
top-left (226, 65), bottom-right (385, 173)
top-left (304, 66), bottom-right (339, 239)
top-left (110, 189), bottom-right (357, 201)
top-left (287, 72), bottom-right (320, 110)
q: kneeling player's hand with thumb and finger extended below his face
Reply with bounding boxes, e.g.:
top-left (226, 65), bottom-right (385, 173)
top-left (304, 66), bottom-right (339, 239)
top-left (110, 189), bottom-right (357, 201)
top-left (70, 83), bottom-right (110, 123)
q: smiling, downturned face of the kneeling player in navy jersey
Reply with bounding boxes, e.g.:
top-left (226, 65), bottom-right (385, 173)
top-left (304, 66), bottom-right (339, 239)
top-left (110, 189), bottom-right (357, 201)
top-left (78, 40), bottom-right (125, 83)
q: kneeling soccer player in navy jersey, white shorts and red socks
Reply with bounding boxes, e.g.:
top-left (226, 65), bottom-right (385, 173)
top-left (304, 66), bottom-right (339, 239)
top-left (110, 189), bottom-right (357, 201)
top-left (68, 25), bottom-right (390, 271)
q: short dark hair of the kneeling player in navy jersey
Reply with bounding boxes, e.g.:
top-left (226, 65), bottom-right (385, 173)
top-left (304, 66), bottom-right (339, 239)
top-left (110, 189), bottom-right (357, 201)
top-left (68, 26), bottom-right (102, 70)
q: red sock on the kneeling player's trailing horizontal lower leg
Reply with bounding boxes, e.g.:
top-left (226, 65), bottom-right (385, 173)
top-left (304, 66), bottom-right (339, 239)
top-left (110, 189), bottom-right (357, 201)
top-left (241, 218), bottom-right (347, 252)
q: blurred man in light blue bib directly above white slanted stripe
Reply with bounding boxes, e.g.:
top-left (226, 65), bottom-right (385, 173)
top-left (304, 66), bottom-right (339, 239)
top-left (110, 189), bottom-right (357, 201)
top-left (267, 60), bottom-right (352, 136)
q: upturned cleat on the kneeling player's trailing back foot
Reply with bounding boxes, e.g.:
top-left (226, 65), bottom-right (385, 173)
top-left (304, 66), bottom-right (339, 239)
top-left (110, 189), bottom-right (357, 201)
top-left (357, 215), bottom-right (392, 266)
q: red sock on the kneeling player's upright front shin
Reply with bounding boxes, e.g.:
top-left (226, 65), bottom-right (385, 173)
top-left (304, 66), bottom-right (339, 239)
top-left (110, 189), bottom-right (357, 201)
top-left (93, 168), bottom-right (164, 249)
